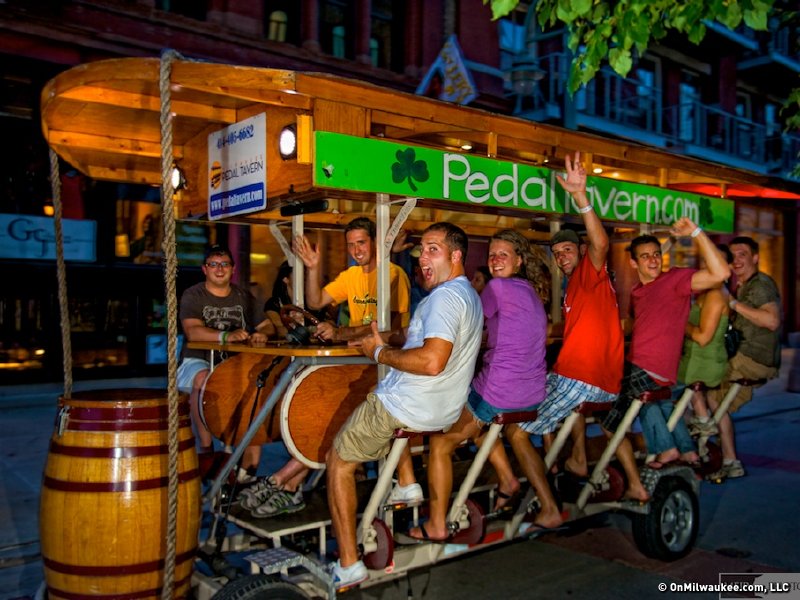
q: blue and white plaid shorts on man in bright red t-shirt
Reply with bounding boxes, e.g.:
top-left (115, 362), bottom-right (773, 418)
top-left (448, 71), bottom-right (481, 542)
top-left (519, 373), bottom-right (617, 435)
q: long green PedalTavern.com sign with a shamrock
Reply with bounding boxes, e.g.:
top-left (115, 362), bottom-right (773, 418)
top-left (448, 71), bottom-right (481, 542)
top-left (314, 131), bottom-right (734, 233)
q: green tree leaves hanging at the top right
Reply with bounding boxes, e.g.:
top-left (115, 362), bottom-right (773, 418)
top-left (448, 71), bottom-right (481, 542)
top-left (483, 0), bottom-right (775, 92)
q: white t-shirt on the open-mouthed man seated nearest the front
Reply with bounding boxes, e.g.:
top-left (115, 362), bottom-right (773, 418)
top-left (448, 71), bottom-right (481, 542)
top-left (375, 275), bottom-right (483, 431)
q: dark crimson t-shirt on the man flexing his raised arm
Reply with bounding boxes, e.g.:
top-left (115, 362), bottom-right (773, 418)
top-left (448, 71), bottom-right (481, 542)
top-left (628, 268), bottom-right (696, 385)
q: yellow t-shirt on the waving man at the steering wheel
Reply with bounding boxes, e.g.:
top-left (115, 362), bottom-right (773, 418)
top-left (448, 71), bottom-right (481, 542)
top-left (324, 263), bottom-right (411, 327)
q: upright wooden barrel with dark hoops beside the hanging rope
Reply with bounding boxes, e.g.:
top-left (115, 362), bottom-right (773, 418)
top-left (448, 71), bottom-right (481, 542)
top-left (39, 389), bottom-right (200, 600)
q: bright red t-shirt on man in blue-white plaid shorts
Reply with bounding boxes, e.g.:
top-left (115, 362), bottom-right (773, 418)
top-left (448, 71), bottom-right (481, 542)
top-left (553, 256), bottom-right (625, 394)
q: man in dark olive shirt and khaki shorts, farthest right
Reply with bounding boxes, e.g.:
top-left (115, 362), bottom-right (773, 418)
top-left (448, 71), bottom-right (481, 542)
top-left (708, 236), bottom-right (782, 479)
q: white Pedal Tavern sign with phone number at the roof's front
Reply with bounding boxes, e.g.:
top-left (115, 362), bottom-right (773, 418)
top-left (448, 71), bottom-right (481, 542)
top-left (208, 113), bottom-right (267, 219)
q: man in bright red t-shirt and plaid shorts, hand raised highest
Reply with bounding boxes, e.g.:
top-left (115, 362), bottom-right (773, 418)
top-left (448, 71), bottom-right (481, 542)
top-left (522, 152), bottom-right (650, 501)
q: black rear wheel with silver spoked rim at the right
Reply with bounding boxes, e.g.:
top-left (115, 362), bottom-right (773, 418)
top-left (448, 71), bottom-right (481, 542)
top-left (632, 477), bottom-right (700, 561)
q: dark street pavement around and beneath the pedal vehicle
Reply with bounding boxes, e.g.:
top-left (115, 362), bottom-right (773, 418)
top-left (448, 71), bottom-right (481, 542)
top-left (0, 349), bottom-right (800, 600)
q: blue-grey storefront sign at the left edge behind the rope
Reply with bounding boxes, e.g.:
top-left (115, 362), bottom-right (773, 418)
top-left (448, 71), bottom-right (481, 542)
top-left (0, 214), bottom-right (97, 262)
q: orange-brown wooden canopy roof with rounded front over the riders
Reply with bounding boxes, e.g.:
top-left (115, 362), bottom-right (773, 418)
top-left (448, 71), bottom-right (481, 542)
top-left (42, 58), bottom-right (798, 233)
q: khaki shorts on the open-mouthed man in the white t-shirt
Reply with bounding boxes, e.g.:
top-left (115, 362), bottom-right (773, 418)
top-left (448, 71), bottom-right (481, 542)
top-left (333, 393), bottom-right (405, 463)
